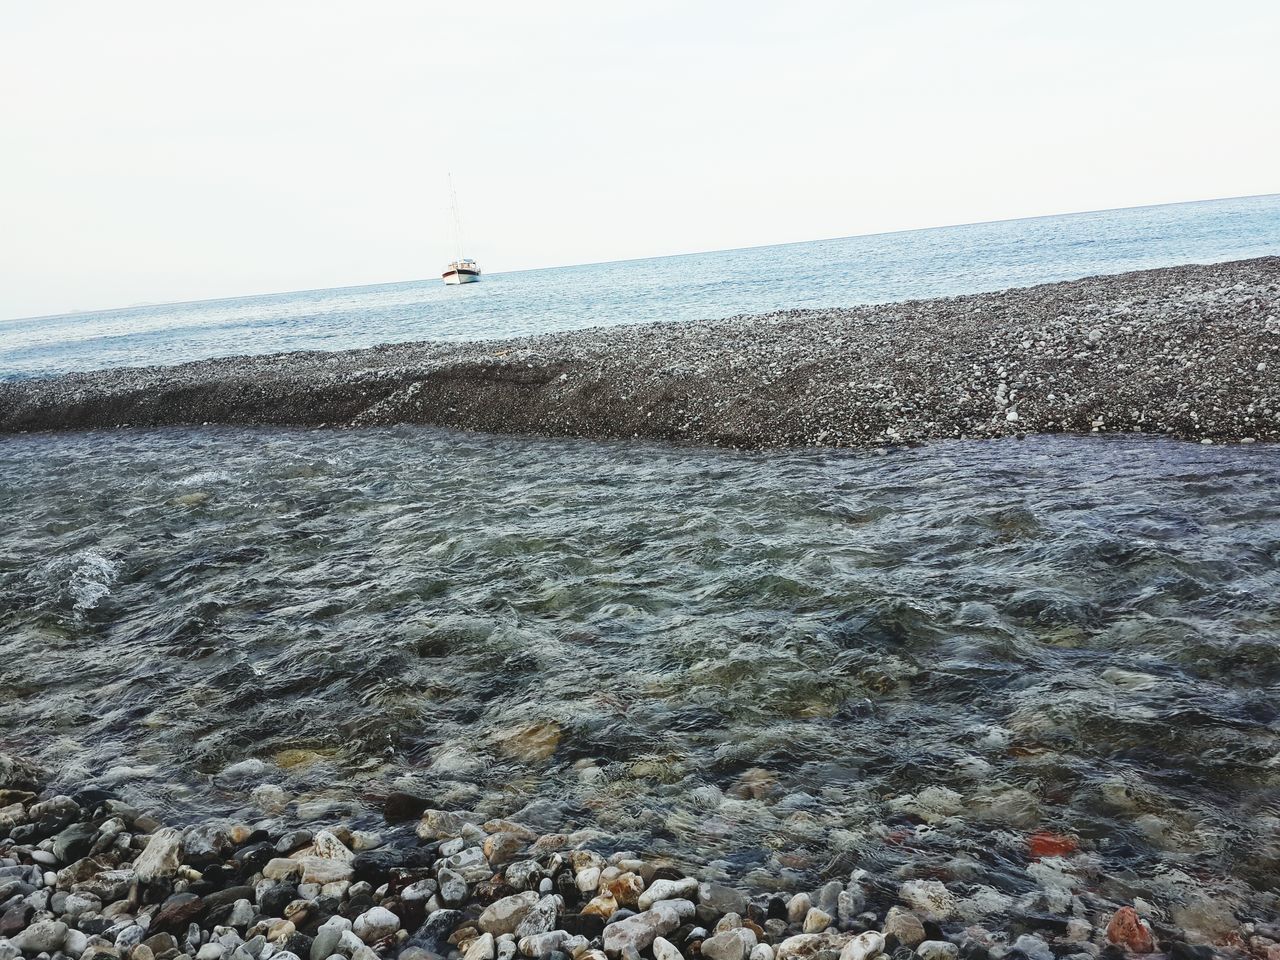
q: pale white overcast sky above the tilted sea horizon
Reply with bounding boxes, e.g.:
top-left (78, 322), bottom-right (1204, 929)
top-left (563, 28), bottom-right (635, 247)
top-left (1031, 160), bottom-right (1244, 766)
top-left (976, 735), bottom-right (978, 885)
top-left (0, 0), bottom-right (1280, 317)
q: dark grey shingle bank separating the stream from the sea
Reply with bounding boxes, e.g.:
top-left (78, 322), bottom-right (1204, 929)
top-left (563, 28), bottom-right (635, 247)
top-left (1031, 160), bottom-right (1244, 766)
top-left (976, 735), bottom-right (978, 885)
top-left (0, 257), bottom-right (1280, 448)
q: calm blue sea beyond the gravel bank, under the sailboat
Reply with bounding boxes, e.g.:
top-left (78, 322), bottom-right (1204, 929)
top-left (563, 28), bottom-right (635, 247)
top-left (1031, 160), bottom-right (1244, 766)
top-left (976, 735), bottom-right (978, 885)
top-left (0, 195), bottom-right (1280, 378)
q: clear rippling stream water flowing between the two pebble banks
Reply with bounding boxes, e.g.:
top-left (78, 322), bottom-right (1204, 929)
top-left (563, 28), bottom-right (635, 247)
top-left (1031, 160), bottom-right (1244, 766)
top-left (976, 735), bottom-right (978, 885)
top-left (0, 428), bottom-right (1280, 916)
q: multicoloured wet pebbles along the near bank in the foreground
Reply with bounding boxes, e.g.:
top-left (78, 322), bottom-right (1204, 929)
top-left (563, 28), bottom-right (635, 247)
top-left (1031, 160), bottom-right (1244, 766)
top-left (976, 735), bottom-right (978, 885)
top-left (0, 754), bottom-right (1264, 960)
